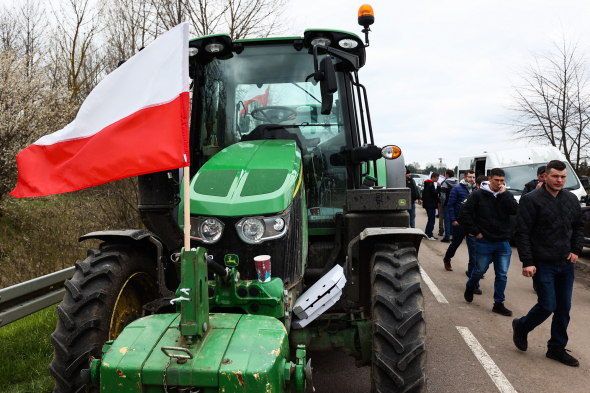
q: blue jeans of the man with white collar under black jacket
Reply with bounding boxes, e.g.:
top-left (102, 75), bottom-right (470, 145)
top-left (467, 237), bottom-right (512, 303)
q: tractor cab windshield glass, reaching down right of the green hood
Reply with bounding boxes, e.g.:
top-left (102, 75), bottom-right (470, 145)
top-left (198, 45), bottom-right (351, 227)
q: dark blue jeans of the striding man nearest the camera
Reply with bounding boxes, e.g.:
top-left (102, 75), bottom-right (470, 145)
top-left (519, 262), bottom-right (575, 348)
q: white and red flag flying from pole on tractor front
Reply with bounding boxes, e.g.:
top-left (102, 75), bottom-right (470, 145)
top-left (10, 23), bottom-right (190, 198)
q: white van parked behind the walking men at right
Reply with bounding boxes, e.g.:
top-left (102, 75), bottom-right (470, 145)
top-left (458, 146), bottom-right (590, 203)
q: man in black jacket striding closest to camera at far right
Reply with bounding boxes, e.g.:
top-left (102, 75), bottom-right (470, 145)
top-left (512, 160), bottom-right (584, 366)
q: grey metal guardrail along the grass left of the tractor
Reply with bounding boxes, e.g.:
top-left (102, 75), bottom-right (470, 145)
top-left (0, 266), bottom-right (76, 327)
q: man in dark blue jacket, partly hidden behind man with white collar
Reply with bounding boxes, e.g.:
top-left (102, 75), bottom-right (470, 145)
top-left (443, 169), bottom-right (481, 274)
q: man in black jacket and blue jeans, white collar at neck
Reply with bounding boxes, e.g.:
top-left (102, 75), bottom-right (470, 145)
top-left (460, 168), bottom-right (518, 316)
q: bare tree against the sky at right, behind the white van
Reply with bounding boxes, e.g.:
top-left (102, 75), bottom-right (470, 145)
top-left (508, 35), bottom-right (590, 170)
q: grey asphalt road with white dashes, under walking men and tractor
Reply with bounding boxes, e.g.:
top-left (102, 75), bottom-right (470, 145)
top-left (308, 208), bottom-right (590, 393)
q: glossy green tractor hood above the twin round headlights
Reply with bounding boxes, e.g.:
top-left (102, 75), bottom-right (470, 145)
top-left (187, 139), bottom-right (301, 217)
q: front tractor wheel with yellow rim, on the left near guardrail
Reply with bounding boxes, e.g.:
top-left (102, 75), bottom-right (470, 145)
top-left (49, 243), bottom-right (158, 393)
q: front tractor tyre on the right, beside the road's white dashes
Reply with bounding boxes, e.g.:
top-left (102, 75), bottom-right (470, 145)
top-left (371, 244), bottom-right (426, 393)
